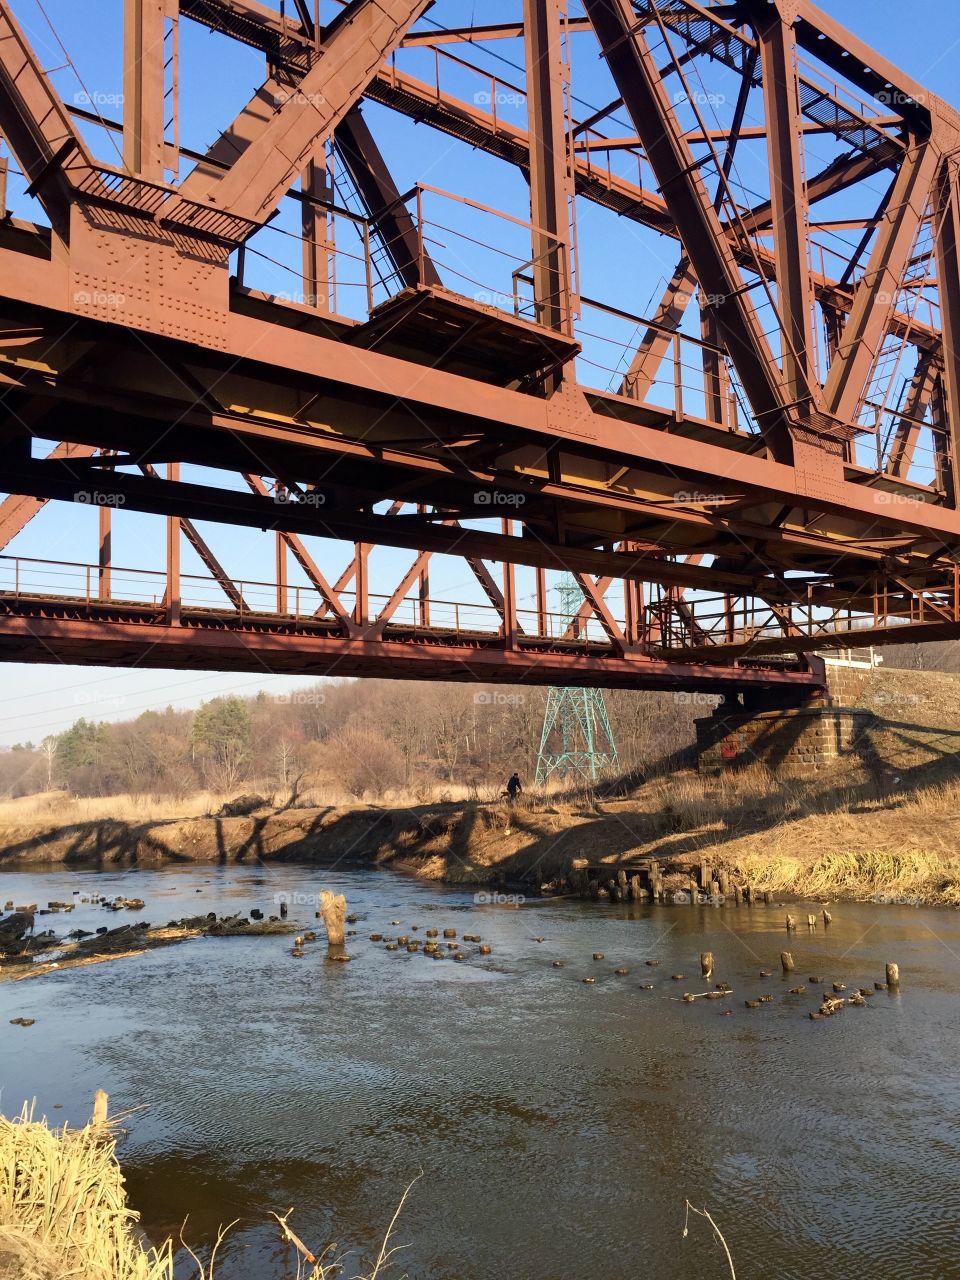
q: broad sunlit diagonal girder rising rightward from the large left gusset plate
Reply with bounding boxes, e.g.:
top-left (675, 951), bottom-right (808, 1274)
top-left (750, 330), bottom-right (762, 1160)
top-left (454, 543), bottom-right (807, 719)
top-left (180, 0), bottom-right (430, 224)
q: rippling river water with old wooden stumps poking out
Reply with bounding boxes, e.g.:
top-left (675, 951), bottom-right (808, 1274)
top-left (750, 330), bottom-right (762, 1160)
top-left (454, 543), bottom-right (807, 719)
top-left (0, 865), bottom-right (960, 1280)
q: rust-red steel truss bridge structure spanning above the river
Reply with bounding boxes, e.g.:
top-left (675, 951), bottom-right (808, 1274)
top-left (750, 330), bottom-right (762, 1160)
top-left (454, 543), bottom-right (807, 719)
top-left (0, 0), bottom-right (960, 696)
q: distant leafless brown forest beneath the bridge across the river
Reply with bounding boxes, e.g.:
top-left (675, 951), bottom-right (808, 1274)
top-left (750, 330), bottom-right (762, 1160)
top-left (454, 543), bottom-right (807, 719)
top-left (0, 680), bottom-right (717, 799)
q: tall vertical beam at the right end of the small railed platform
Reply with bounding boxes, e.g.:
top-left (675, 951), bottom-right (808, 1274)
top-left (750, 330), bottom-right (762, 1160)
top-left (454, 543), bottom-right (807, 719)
top-left (524, 0), bottom-right (573, 334)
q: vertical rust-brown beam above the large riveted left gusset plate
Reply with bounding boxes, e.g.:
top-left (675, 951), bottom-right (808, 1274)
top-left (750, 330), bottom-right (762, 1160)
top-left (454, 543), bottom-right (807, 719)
top-left (123, 0), bottom-right (166, 182)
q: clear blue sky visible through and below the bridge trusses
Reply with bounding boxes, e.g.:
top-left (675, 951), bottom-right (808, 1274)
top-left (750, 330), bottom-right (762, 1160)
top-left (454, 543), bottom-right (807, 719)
top-left (0, 0), bottom-right (960, 745)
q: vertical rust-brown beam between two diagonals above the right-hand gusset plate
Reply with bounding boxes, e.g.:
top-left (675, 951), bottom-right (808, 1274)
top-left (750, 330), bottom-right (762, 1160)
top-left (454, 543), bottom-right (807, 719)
top-left (756, 8), bottom-right (814, 402)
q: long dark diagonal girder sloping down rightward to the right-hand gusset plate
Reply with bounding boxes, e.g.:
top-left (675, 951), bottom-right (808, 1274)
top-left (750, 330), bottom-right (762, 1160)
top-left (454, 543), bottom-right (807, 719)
top-left (584, 0), bottom-right (813, 461)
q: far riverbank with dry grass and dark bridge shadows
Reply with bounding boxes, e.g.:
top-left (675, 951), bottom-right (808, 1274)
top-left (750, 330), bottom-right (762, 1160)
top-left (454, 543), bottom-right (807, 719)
top-left (0, 769), bottom-right (960, 905)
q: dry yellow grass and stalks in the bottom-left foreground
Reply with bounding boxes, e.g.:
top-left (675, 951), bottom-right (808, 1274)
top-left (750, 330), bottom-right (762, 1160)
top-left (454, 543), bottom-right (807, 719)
top-left (0, 1106), bottom-right (412, 1280)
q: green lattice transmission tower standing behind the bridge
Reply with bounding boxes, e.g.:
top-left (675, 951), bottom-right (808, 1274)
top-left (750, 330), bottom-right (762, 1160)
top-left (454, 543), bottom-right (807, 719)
top-left (536, 573), bottom-right (620, 786)
